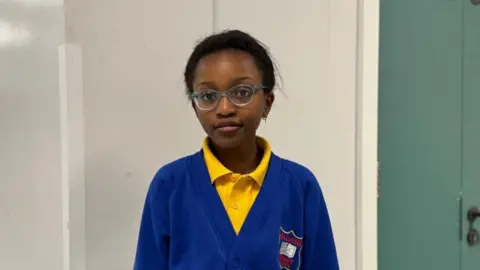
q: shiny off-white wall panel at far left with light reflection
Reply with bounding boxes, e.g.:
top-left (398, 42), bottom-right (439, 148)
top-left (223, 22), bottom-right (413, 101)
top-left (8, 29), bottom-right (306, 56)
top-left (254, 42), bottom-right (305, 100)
top-left (0, 0), bottom-right (65, 270)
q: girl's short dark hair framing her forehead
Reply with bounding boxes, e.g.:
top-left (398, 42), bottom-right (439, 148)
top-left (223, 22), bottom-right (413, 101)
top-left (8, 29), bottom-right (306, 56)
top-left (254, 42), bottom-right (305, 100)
top-left (184, 30), bottom-right (275, 94)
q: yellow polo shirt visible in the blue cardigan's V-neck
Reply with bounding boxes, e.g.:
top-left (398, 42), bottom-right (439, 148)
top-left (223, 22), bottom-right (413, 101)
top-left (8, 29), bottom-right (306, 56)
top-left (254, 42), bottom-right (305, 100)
top-left (203, 137), bottom-right (272, 234)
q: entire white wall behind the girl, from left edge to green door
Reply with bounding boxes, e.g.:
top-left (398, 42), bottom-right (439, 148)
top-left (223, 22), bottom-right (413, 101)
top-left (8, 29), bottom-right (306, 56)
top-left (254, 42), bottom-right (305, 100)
top-left (0, 0), bottom-right (378, 270)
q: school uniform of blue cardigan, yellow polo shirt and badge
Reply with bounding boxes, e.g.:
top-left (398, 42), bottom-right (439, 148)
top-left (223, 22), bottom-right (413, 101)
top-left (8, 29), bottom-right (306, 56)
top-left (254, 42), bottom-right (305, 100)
top-left (134, 137), bottom-right (339, 270)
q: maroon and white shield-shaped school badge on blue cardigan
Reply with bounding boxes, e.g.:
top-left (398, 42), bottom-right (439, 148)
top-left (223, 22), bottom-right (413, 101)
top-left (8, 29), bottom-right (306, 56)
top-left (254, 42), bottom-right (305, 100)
top-left (279, 227), bottom-right (303, 270)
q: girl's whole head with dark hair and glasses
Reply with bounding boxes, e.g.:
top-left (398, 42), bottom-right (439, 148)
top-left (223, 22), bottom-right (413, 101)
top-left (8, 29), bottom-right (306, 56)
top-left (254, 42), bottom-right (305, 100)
top-left (184, 30), bottom-right (275, 148)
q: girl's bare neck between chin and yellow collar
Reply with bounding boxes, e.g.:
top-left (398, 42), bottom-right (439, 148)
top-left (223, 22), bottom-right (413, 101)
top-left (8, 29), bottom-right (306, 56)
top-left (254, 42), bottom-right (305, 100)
top-left (210, 138), bottom-right (263, 174)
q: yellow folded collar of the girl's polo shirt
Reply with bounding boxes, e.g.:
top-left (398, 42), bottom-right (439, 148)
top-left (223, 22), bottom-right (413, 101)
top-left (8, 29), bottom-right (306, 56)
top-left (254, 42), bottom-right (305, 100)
top-left (203, 137), bottom-right (272, 186)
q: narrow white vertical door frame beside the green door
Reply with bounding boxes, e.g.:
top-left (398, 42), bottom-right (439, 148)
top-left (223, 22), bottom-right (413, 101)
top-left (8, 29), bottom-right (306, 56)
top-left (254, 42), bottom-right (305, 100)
top-left (355, 0), bottom-right (380, 270)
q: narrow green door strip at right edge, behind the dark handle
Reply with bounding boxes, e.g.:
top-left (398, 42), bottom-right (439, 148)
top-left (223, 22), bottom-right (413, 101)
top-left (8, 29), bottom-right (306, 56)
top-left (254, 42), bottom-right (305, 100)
top-left (461, 0), bottom-right (480, 270)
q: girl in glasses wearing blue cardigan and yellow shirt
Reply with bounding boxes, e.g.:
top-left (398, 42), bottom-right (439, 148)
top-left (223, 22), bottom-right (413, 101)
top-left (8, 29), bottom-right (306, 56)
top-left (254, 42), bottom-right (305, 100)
top-left (134, 31), bottom-right (339, 270)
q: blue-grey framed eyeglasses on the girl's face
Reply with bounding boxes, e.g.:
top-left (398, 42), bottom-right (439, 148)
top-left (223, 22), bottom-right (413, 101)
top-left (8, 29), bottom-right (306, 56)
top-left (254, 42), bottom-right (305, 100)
top-left (191, 84), bottom-right (266, 111)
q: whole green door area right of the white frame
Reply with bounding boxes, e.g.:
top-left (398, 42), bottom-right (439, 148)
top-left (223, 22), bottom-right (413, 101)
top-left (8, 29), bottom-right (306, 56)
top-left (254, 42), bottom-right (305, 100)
top-left (379, 0), bottom-right (480, 270)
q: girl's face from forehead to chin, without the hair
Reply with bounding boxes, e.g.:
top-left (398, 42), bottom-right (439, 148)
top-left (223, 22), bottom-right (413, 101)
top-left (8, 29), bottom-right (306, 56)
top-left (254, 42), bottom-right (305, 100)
top-left (193, 50), bottom-right (274, 148)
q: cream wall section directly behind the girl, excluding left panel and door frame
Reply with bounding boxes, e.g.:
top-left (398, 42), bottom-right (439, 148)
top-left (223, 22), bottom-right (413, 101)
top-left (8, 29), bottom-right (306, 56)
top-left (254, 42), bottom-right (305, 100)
top-left (67, 0), bottom-right (357, 270)
